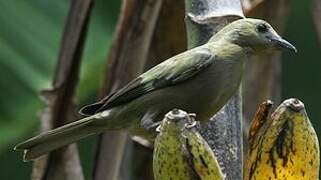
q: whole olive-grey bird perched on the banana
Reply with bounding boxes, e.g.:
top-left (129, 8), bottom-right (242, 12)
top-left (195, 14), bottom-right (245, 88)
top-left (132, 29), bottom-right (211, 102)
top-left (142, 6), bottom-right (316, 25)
top-left (14, 18), bottom-right (297, 161)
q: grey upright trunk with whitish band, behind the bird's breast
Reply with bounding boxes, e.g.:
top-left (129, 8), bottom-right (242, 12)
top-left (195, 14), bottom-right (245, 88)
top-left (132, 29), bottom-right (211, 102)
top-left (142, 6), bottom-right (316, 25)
top-left (185, 0), bottom-right (243, 180)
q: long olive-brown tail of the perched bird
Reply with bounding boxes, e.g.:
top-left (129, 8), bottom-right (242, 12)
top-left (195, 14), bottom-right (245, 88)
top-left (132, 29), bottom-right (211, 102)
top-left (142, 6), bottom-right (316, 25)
top-left (14, 117), bottom-right (97, 161)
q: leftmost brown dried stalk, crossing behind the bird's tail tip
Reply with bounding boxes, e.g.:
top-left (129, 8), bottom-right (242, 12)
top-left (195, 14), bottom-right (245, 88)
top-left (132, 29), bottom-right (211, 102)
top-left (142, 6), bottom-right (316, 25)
top-left (32, 0), bottom-right (93, 180)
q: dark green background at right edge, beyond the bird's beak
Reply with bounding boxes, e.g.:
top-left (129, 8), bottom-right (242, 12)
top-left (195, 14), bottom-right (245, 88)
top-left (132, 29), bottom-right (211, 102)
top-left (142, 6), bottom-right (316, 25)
top-left (282, 0), bottom-right (321, 141)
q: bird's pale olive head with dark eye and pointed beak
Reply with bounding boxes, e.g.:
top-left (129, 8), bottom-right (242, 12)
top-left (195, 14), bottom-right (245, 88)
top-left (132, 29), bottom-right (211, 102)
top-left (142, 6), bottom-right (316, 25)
top-left (212, 18), bottom-right (297, 52)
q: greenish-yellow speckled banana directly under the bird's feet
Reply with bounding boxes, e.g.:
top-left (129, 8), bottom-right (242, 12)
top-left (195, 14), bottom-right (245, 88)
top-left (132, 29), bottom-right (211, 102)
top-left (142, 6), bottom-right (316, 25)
top-left (153, 109), bottom-right (225, 180)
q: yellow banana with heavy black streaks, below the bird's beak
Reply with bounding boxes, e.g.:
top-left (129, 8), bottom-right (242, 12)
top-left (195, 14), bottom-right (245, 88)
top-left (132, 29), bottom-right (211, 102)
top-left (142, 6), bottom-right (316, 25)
top-left (243, 98), bottom-right (320, 180)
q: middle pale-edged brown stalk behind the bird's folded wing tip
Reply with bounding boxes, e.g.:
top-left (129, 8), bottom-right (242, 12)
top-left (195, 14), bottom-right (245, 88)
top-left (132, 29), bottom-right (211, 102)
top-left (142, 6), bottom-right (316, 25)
top-left (93, 0), bottom-right (162, 180)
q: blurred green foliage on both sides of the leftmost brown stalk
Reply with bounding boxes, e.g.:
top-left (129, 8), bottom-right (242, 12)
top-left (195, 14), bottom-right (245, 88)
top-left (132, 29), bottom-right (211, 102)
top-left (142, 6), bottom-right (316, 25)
top-left (0, 0), bottom-right (120, 179)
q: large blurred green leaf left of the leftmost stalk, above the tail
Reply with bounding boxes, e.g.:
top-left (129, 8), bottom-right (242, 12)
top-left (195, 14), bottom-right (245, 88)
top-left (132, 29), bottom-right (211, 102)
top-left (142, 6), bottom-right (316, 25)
top-left (0, 1), bottom-right (66, 150)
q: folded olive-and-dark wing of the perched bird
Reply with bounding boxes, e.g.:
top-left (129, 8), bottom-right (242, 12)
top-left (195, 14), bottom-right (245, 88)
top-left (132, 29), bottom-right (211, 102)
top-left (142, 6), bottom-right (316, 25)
top-left (80, 48), bottom-right (215, 115)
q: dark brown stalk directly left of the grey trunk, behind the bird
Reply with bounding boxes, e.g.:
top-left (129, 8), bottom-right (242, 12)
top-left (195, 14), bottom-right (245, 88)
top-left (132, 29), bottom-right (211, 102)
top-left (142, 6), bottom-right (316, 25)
top-left (132, 0), bottom-right (187, 180)
